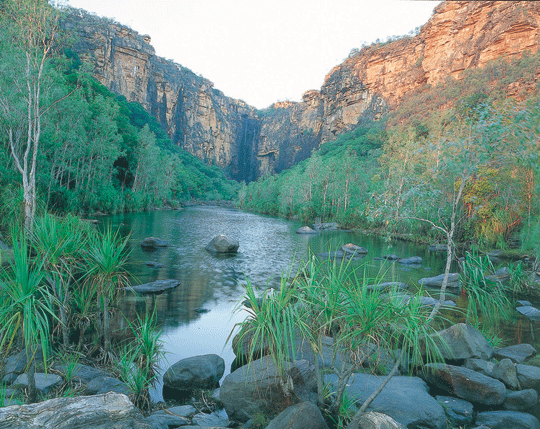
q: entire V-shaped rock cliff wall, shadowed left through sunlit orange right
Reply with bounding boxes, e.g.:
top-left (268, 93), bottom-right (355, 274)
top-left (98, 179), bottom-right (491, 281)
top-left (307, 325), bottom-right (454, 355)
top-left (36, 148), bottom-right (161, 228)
top-left (66, 1), bottom-right (540, 181)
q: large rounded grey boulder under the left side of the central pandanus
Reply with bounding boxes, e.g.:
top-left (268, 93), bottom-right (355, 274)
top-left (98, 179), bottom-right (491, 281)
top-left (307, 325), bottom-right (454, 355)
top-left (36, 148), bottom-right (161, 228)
top-left (219, 356), bottom-right (303, 422)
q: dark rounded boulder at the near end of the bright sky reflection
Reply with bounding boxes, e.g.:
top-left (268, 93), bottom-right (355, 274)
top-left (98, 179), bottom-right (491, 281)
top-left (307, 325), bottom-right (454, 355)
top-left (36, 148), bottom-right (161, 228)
top-left (163, 354), bottom-right (225, 392)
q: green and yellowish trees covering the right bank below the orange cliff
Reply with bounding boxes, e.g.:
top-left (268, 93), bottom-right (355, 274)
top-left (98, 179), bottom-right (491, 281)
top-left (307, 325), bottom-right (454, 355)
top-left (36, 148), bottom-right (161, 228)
top-left (239, 54), bottom-right (540, 246)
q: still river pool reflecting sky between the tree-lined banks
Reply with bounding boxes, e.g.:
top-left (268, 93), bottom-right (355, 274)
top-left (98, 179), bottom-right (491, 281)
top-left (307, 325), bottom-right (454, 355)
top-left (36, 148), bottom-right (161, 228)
top-left (100, 206), bottom-right (456, 401)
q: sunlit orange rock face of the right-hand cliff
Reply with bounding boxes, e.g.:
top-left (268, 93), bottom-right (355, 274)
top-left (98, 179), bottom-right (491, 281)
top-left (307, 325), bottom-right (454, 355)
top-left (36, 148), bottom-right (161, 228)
top-left (321, 1), bottom-right (540, 142)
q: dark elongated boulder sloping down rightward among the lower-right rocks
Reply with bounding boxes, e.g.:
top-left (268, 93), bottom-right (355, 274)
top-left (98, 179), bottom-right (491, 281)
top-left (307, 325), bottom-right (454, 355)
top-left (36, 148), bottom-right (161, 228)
top-left (422, 363), bottom-right (506, 405)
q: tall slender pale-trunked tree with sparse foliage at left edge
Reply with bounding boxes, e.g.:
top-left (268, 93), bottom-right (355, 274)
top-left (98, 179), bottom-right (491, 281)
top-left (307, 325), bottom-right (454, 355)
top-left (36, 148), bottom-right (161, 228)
top-left (0, 0), bottom-right (71, 230)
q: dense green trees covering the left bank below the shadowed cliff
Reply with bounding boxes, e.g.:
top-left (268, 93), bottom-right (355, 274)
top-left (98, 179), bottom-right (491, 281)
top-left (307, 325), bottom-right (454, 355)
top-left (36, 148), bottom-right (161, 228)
top-left (0, 0), bottom-right (237, 226)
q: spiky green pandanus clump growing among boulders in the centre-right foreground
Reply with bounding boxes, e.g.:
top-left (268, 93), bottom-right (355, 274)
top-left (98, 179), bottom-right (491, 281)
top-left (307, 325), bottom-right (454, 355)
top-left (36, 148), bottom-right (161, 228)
top-left (234, 257), bottom-right (450, 421)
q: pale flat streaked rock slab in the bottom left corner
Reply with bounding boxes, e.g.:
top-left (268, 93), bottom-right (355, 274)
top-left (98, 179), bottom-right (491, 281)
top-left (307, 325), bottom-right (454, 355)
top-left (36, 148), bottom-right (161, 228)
top-left (0, 393), bottom-right (152, 429)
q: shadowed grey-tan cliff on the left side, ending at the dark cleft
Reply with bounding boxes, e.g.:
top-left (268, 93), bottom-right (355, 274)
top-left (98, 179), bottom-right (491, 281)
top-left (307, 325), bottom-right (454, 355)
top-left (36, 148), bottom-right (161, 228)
top-left (65, 10), bottom-right (260, 181)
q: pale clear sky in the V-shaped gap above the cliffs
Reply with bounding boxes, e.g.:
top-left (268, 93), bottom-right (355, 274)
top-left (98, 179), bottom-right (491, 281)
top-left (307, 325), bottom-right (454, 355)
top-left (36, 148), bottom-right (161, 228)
top-left (65, 0), bottom-right (440, 108)
